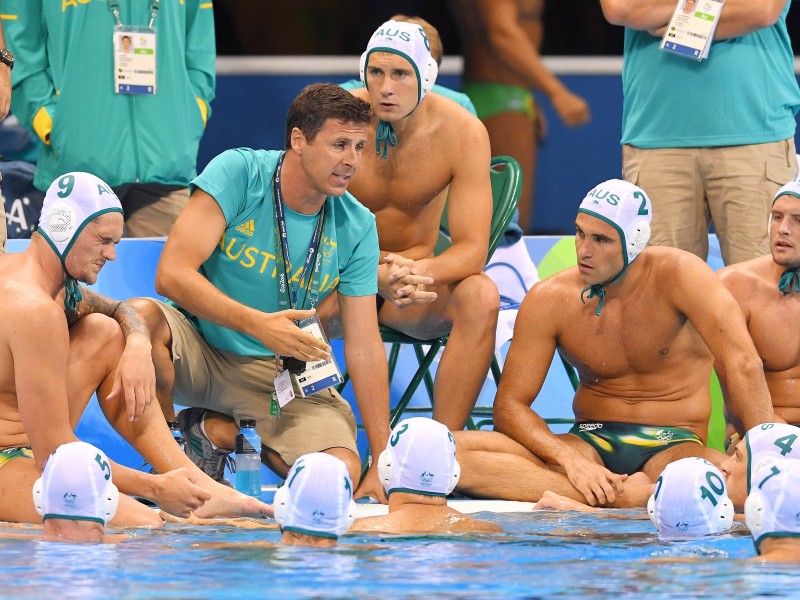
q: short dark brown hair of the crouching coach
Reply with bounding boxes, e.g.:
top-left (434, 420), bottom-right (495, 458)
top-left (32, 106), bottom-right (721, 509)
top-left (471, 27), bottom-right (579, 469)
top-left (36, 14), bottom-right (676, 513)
top-left (286, 83), bottom-right (372, 149)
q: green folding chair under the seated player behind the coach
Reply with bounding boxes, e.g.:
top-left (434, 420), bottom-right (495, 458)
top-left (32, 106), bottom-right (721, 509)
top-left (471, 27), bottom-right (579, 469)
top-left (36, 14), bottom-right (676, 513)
top-left (339, 156), bottom-right (522, 429)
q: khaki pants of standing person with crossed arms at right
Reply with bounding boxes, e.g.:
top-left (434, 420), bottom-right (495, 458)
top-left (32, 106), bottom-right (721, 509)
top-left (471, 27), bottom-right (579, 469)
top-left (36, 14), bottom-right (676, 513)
top-left (622, 138), bottom-right (797, 264)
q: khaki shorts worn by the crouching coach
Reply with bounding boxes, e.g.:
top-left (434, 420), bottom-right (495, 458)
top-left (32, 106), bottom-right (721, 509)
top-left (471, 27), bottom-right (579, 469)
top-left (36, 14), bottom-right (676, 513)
top-left (148, 298), bottom-right (358, 466)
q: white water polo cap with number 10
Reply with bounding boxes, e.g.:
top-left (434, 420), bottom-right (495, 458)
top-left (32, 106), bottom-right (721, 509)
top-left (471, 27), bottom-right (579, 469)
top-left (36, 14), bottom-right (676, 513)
top-left (647, 457), bottom-right (734, 539)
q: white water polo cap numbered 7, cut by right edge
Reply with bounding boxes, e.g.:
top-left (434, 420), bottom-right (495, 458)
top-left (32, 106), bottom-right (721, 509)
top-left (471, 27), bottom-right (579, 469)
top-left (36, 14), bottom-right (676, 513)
top-left (744, 458), bottom-right (800, 554)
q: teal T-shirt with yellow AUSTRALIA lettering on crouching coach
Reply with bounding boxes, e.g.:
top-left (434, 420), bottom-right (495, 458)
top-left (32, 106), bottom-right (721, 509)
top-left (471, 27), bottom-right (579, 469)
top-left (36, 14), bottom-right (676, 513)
top-left (184, 148), bottom-right (380, 356)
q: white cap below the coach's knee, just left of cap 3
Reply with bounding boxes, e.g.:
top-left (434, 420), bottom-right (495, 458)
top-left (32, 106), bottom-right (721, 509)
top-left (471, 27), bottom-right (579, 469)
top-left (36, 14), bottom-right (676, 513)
top-left (273, 452), bottom-right (356, 539)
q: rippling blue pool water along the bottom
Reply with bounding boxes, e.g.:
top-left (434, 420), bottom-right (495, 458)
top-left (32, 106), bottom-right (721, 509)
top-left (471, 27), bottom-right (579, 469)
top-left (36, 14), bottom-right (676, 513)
top-left (0, 511), bottom-right (800, 599)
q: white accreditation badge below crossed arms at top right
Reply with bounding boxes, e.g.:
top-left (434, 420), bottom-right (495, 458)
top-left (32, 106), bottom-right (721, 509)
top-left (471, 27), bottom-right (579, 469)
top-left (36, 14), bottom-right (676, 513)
top-left (660, 0), bottom-right (725, 61)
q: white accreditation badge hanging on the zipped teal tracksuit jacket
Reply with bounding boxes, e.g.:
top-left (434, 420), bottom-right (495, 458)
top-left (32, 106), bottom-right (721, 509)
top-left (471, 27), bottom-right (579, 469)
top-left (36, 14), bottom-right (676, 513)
top-left (114, 25), bottom-right (156, 96)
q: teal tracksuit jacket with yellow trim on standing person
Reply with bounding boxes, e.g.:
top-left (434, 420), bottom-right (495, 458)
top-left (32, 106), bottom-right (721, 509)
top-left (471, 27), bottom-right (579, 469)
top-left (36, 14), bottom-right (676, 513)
top-left (2, 0), bottom-right (216, 190)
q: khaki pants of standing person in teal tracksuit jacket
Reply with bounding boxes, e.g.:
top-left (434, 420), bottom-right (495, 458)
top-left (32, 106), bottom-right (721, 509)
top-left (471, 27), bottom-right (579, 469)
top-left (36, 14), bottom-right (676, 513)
top-left (114, 183), bottom-right (189, 237)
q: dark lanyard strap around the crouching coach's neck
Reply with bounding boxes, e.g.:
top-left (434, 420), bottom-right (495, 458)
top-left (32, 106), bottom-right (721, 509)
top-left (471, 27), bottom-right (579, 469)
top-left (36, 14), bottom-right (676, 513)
top-left (272, 153), bottom-right (325, 309)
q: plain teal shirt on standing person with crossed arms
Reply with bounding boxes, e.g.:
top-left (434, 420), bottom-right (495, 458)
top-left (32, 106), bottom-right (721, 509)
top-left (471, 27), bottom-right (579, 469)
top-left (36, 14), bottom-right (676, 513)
top-left (622, 1), bottom-right (800, 148)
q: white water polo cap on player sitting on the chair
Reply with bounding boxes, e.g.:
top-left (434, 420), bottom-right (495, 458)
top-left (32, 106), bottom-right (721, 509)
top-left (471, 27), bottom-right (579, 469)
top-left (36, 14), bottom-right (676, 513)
top-left (359, 21), bottom-right (439, 103)
